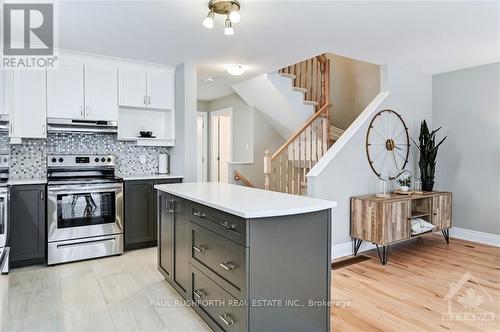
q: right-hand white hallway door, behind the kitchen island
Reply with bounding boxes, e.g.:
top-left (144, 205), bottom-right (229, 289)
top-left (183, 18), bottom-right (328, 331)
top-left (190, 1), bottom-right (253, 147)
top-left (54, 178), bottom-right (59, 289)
top-left (210, 108), bottom-right (233, 183)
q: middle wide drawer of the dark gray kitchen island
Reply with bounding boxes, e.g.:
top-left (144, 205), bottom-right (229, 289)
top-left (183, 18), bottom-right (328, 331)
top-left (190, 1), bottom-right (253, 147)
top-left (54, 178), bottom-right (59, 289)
top-left (189, 222), bottom-right (247, 299)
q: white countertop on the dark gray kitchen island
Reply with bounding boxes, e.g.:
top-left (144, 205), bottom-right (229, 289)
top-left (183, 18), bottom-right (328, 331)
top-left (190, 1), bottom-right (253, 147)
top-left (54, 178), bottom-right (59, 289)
top-left (155, 182), bottom-right (337, 219)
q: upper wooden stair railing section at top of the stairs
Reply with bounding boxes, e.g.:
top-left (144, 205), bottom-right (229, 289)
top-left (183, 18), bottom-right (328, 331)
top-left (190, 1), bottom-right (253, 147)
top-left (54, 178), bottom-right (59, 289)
top-left (279, 54), bottom-right (330, 111)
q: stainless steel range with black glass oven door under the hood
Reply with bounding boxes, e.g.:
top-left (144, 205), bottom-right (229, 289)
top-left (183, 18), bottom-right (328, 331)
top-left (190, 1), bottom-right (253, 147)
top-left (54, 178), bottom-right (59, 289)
top-left (47, 155), bottom-right (123, 265)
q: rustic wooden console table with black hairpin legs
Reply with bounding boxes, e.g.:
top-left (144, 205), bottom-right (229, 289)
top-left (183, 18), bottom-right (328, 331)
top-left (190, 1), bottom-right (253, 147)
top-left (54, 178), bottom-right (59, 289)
top-left (351, 191), bottom-right (452, 265)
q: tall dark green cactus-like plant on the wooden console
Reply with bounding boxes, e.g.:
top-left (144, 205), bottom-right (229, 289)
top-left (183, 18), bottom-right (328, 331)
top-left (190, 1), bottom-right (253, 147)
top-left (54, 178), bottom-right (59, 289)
top-left (412, 120), bottom-right (446, 191)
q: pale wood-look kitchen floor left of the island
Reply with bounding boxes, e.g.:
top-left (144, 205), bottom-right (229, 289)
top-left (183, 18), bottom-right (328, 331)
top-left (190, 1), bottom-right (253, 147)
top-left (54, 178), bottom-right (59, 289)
top-left (0, 248), bottom-right (211, 332)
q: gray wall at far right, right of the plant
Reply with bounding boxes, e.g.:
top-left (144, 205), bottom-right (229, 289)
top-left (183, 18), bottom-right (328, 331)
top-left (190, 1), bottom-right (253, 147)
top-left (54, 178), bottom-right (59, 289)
top-left (432, 63), bottom-right (500, 235)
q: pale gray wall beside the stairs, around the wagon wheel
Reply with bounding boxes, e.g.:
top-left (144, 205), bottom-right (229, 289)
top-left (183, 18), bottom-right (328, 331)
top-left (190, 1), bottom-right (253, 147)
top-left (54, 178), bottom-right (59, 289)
top-left (307, 65), bottom-right (432, 249)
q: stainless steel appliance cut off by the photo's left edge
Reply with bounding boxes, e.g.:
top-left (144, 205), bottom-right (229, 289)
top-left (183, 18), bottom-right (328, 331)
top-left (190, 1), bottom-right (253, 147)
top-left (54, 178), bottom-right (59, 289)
top-left (0, 154), bottom-right (9, 273)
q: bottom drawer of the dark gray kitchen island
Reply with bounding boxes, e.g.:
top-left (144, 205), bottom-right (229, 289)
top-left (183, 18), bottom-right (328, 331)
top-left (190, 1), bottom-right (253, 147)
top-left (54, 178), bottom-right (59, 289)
top-left (189, 265), bottom-right (246, 332)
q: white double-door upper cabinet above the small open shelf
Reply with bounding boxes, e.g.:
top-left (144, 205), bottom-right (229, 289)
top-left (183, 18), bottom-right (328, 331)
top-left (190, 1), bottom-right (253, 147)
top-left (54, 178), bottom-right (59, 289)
top-left (118, 68), bottom-right (174, 110)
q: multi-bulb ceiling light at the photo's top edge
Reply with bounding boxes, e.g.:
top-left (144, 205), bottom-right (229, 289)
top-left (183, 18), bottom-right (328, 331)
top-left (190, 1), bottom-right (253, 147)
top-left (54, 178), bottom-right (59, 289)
top-left (203, 0), bottom-right (241, 36)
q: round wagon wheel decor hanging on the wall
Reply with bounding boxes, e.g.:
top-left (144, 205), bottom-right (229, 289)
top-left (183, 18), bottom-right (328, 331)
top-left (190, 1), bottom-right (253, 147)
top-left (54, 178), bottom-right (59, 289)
top-left (366, 110), bottom-right (410, 180)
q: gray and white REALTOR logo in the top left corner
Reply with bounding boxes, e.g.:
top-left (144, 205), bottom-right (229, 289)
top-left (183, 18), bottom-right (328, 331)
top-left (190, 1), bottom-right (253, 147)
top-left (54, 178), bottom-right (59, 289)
top-left (2, 2), bottom-right (57, 70)
